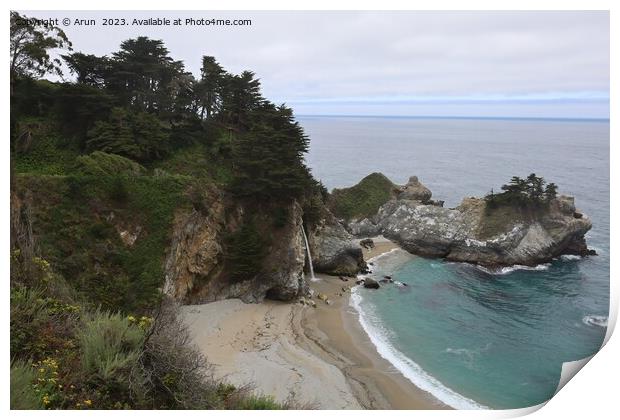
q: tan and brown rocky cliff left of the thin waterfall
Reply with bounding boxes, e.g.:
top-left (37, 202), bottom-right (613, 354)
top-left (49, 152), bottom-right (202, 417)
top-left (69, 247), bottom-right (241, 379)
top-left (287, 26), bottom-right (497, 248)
top-left (164, 189), bottom-right (308, 303)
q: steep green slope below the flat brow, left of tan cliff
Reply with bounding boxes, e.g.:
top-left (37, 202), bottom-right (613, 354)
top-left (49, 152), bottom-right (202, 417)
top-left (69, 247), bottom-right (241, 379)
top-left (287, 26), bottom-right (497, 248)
top-left (15, 174), bottom-right (188, 311)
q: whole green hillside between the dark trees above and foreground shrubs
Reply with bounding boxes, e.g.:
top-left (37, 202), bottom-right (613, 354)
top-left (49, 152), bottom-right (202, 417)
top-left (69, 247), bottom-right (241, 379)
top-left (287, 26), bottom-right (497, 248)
top-left (11, 119), bottom-right (230, 311)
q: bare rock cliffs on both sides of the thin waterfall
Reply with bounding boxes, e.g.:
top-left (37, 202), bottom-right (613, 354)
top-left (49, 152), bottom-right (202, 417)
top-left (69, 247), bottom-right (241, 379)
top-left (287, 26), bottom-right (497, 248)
top-left (164, 191), bottom-right (365, 303)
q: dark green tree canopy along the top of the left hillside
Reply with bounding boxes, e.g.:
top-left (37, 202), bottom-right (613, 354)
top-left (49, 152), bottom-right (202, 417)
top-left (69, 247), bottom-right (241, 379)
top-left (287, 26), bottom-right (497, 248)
top-left (11, 14), bottom-right (315, 201)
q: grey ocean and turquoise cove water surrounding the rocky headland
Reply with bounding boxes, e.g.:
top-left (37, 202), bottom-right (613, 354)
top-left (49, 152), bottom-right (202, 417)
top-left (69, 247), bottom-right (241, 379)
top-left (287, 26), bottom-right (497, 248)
top-left (298, 117), bottom-right (610, 409)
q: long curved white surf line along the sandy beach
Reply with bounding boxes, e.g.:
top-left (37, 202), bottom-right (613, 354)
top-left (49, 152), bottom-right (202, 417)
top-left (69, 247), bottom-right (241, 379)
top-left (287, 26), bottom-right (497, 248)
top-left (349, 286), bottom-right (488, 410)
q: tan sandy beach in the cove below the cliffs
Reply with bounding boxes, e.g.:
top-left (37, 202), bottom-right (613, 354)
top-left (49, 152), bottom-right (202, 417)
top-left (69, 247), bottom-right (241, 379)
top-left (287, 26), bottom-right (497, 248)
top-left (183, 237), bottom-right (448, 409)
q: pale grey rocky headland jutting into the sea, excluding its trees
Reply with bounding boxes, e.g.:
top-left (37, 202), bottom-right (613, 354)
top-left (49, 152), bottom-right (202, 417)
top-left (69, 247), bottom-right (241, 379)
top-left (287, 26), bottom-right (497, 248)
top-left (348, 178), bottom-right (592, 266)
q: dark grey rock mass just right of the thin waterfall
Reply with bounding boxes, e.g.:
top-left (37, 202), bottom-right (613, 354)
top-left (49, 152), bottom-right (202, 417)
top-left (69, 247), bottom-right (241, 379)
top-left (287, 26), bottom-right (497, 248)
top-left (308, 210), bottom-right (366, 276)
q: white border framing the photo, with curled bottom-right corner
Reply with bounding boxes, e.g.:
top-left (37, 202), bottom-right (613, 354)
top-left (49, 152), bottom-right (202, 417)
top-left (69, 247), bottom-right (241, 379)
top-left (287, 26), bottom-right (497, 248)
top-left (0, 0), bottom-right (620, 419)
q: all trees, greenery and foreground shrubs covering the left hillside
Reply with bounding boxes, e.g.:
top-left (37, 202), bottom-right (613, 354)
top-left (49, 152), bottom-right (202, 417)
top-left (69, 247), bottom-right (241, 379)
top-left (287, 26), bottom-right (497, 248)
top-left (10, 13), bottom-right (325, 408)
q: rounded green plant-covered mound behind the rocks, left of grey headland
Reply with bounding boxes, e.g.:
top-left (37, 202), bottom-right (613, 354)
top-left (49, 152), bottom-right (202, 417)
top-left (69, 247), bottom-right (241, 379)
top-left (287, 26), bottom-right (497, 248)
top-left (328, 172), bottom-right (397, 219)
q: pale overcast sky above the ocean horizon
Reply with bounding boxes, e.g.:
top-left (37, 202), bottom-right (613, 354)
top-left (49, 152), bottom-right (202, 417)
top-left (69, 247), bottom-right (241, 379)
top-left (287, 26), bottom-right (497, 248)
top-left (24, 11), bottom-right (609, 118)
